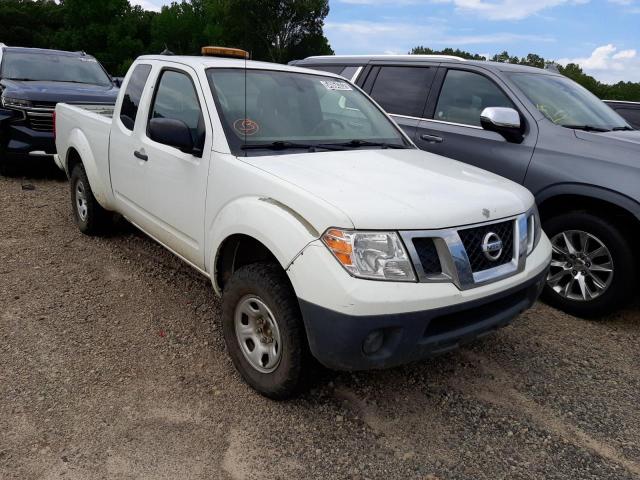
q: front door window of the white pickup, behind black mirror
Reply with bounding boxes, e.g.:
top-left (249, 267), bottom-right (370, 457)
top-left (149, 70), bottom-right (204, 145)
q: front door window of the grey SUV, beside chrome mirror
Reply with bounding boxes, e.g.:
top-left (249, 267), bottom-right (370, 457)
top-left (434, 70), bottom-right (514, 127)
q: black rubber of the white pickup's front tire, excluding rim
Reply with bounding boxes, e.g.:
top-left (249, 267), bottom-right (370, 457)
top-left (222, 263), bottom-right (310, 400)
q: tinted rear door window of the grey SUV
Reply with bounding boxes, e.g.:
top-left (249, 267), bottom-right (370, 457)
top-left (371, 66), bottom-right (436, 117)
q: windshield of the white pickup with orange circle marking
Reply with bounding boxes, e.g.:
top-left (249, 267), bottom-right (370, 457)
top-left (207, 68), bottom-right (410, 156)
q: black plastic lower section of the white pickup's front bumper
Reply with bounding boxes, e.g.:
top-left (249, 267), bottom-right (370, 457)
top-left (300, 270), bottom-right (547, 370)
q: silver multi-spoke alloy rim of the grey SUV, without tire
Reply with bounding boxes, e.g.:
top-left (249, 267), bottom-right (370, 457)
top-left (547, 230), bottom-right (613, 302)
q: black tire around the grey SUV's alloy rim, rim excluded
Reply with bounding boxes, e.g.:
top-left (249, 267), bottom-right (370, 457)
top-left (542, 211), bottom-right (638, 318)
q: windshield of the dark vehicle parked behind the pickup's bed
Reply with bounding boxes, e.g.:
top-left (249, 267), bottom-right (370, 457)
top-left (2, 51), bottom-right (112, 87)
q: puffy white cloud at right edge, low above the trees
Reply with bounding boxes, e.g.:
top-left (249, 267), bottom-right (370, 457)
top-left (558, 43), bottom-right (640, 83)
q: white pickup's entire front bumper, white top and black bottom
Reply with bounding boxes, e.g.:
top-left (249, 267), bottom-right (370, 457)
top-left (288, 235), bottom-right (551, 370)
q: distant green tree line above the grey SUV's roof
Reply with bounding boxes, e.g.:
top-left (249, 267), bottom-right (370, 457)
top-left (409, 47), bottom-right (640, 102)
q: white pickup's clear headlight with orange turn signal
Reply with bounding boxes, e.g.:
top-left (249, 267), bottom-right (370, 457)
top-left (322, 228), bottom-right (416, 282)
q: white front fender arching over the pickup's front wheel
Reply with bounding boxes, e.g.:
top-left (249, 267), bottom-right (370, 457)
top-left (207, 197), bottom-right (321, 293)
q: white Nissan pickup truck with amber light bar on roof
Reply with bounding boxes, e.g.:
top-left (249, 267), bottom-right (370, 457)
top-left (56, 50), bottom-right (551, 398)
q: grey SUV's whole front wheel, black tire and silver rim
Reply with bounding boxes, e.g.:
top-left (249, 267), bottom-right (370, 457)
top-left (542, 212), bottom-right (637, 318)
